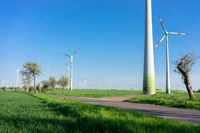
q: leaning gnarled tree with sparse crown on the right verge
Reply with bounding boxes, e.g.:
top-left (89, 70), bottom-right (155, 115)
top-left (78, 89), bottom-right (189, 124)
top-left (174, 53), bottom-right (198, 99)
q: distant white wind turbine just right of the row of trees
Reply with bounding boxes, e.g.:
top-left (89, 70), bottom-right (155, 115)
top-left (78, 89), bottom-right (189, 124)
top-left (64, 51), bottom-right (77, 91)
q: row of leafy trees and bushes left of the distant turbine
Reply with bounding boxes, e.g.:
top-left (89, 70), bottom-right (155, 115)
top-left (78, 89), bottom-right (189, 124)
top-left (20, 62), bottom-right (69, 93)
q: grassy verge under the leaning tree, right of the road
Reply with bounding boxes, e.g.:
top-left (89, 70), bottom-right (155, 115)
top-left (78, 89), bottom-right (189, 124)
top-left (128, 91), bottom-right (200, 110)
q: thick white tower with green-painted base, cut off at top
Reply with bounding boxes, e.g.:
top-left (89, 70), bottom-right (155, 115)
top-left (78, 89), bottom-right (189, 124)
top-left (143, 0), bottom-right (156, 95)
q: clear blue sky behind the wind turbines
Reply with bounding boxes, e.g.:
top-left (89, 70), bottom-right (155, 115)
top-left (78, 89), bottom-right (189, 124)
top-left (0, 0), bottom-right (200, 89)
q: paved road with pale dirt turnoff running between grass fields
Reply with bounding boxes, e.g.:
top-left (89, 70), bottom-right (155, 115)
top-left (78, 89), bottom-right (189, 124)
top-left (59, 96), bottom-right (200, 124)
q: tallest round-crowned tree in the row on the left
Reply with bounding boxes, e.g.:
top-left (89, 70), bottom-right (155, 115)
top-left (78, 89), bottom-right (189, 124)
top-left (21, 62), bottom-right (41, 92)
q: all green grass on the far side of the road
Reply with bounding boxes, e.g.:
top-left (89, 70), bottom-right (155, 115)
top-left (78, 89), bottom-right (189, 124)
top-left (47, 89), bottom-right (200, 110)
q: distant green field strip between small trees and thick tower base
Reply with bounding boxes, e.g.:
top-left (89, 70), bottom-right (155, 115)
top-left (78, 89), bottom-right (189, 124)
top-left (47, 89), bottom-right (142, 98)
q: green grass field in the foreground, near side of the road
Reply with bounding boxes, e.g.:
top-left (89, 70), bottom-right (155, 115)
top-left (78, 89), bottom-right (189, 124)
top-left (0, 92), bottom-right (200, 133)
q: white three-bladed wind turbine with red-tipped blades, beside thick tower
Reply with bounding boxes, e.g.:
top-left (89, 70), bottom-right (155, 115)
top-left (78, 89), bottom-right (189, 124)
top-left (156, 18), bottom-right (186, 94)
